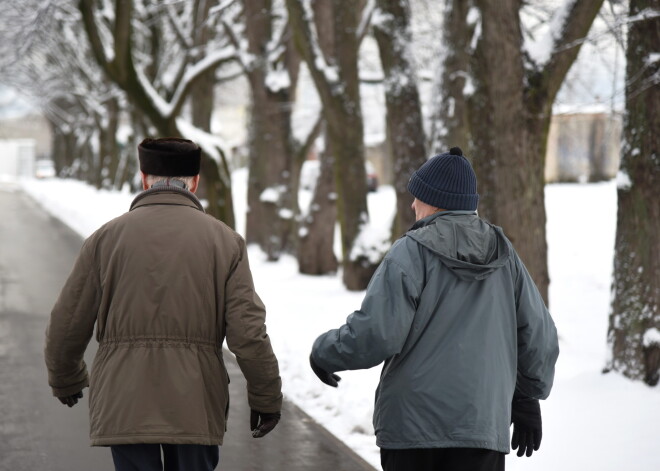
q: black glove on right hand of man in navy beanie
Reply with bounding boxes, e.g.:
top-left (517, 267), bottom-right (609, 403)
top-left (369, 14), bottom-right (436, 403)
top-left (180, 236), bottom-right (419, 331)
top-left (511, 399), bottom-right (543, 456)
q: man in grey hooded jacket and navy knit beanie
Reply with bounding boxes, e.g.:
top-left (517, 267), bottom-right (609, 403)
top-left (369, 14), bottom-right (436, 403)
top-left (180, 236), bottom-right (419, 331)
top-left (310, 147), bottom-right (559, 471)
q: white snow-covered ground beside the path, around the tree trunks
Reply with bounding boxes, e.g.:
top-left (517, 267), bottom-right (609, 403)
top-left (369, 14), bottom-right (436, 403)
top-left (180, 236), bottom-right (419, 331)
top-left (16, 172), bottom-right (660, 471)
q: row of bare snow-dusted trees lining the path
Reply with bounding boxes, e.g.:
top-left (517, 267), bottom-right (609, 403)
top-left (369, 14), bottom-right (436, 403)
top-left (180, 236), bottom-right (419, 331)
top-left (0, 0), bottom-right (660, 388)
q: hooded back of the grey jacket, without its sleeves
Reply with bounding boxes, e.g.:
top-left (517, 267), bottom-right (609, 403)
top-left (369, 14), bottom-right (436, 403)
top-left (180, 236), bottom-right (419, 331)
top-left (374, 211), bottom-right (554, 452)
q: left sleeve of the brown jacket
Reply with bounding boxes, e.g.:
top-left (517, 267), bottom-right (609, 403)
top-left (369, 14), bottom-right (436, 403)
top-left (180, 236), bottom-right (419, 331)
top-left (44, 239), bottom-right (101, 397)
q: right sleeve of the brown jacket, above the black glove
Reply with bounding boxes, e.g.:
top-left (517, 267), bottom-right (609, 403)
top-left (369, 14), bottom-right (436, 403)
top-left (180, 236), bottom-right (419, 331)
top-left (224, 237), bottom-right (282, 412)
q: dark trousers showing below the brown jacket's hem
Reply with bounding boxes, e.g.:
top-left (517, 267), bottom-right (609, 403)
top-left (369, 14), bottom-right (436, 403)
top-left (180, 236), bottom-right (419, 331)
top-left (110, 443), bottom-right (220, 471)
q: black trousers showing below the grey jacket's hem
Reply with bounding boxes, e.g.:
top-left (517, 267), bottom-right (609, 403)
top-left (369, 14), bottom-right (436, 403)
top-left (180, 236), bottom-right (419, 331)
top-left (380, 448), bottom-right (504, 471)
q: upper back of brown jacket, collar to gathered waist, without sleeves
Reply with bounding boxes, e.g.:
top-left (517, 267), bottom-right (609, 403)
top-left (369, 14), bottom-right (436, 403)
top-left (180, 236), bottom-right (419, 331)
top-left (93, 188), bottom-right (240, 344)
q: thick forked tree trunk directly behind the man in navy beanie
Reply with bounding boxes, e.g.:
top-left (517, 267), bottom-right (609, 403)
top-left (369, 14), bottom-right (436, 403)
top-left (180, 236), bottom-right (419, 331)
top-left (441, 0), bottom-right (603, 303)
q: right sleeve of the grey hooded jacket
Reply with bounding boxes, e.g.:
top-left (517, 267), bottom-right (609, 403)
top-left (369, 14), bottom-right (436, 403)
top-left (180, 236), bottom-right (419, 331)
top-left (514, 252), bottom-right (559, 399)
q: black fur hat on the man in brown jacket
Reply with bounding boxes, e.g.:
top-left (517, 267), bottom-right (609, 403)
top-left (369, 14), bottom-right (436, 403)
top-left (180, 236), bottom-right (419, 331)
top-left (138, 137), bottom-right (202, 177)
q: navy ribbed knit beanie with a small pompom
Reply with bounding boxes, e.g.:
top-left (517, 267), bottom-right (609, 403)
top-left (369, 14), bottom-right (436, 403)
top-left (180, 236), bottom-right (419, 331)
top-left (408, 147), bottom-right (479, 211)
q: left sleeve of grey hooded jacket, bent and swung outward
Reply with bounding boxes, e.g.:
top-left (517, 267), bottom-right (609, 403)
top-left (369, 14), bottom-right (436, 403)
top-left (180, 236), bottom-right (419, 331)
top-left (312, 242), bottom-right (422, 372)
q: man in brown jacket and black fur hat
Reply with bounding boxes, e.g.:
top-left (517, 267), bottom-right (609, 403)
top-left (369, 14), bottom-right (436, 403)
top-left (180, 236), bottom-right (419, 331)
top-left (45, 138), bottom-right (282, 471)
